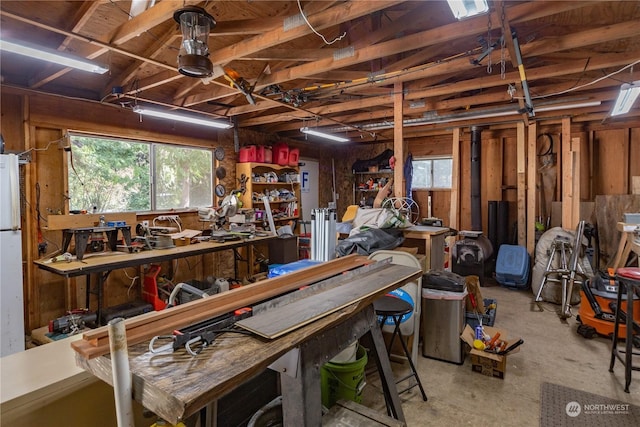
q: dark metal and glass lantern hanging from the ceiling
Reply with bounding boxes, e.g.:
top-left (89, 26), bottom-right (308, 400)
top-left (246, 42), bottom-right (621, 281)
top-left (173, 6), bottom-right (216, 77)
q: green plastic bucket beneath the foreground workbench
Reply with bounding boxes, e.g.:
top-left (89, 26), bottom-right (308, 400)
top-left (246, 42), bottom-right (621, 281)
top-left (320, 346), bottom-right (367, 408)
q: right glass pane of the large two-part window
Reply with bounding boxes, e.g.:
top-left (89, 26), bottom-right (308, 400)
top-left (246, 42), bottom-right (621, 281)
top-left (155, 144), bottom-right (213, 209)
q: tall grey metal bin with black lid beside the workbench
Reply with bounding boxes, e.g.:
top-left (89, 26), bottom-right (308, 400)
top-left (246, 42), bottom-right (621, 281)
top-left (422, 272), bottom-right (467, 364)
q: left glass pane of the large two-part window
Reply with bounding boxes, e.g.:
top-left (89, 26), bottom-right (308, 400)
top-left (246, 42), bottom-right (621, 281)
top-left (69, 135), bottom-right (151, 212)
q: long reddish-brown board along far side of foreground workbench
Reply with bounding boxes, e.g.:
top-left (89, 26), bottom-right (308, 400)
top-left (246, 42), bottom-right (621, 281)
top-left (71, 255), bottom-right (371, 359)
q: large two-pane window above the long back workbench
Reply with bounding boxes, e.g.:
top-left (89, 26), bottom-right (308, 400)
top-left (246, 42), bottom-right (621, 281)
top-left (69, 134), bottom-right (213, 212)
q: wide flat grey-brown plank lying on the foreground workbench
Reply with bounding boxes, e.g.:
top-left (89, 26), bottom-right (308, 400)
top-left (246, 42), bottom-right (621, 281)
top-left (236, 264), bottom-right (422, 339)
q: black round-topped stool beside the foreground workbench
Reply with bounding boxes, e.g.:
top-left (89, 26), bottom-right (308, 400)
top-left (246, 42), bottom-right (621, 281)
top-left (373, 295), bottom-right (427, 401)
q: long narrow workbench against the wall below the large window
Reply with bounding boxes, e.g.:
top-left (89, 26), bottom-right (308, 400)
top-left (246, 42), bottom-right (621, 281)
top-left (34, 236), bottom-right (274, 319)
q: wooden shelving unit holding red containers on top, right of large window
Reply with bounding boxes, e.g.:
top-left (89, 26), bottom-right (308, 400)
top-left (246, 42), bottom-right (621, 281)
top-left (236, 163), bottom-right (301, 226)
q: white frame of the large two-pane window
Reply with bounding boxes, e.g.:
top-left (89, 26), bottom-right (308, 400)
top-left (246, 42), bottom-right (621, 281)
top-left (65, 130), bottom-right (216, 214)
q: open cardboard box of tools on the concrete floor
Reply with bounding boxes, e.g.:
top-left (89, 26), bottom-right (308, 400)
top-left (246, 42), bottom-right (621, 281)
top-left (460, 325), bottom-right (524, 379)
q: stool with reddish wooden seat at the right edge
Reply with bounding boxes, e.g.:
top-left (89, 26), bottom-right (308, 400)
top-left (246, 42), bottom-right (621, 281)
top-left (609, 267), bottom-right (640, 393)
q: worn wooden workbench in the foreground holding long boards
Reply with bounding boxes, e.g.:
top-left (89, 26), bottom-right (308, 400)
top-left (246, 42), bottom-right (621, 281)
top-left (76, 264), bottom-right (422, 426)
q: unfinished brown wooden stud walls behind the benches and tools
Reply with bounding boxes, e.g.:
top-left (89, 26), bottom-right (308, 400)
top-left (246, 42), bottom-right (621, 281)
top-left (0, 84), bottom-right (640, 329)
